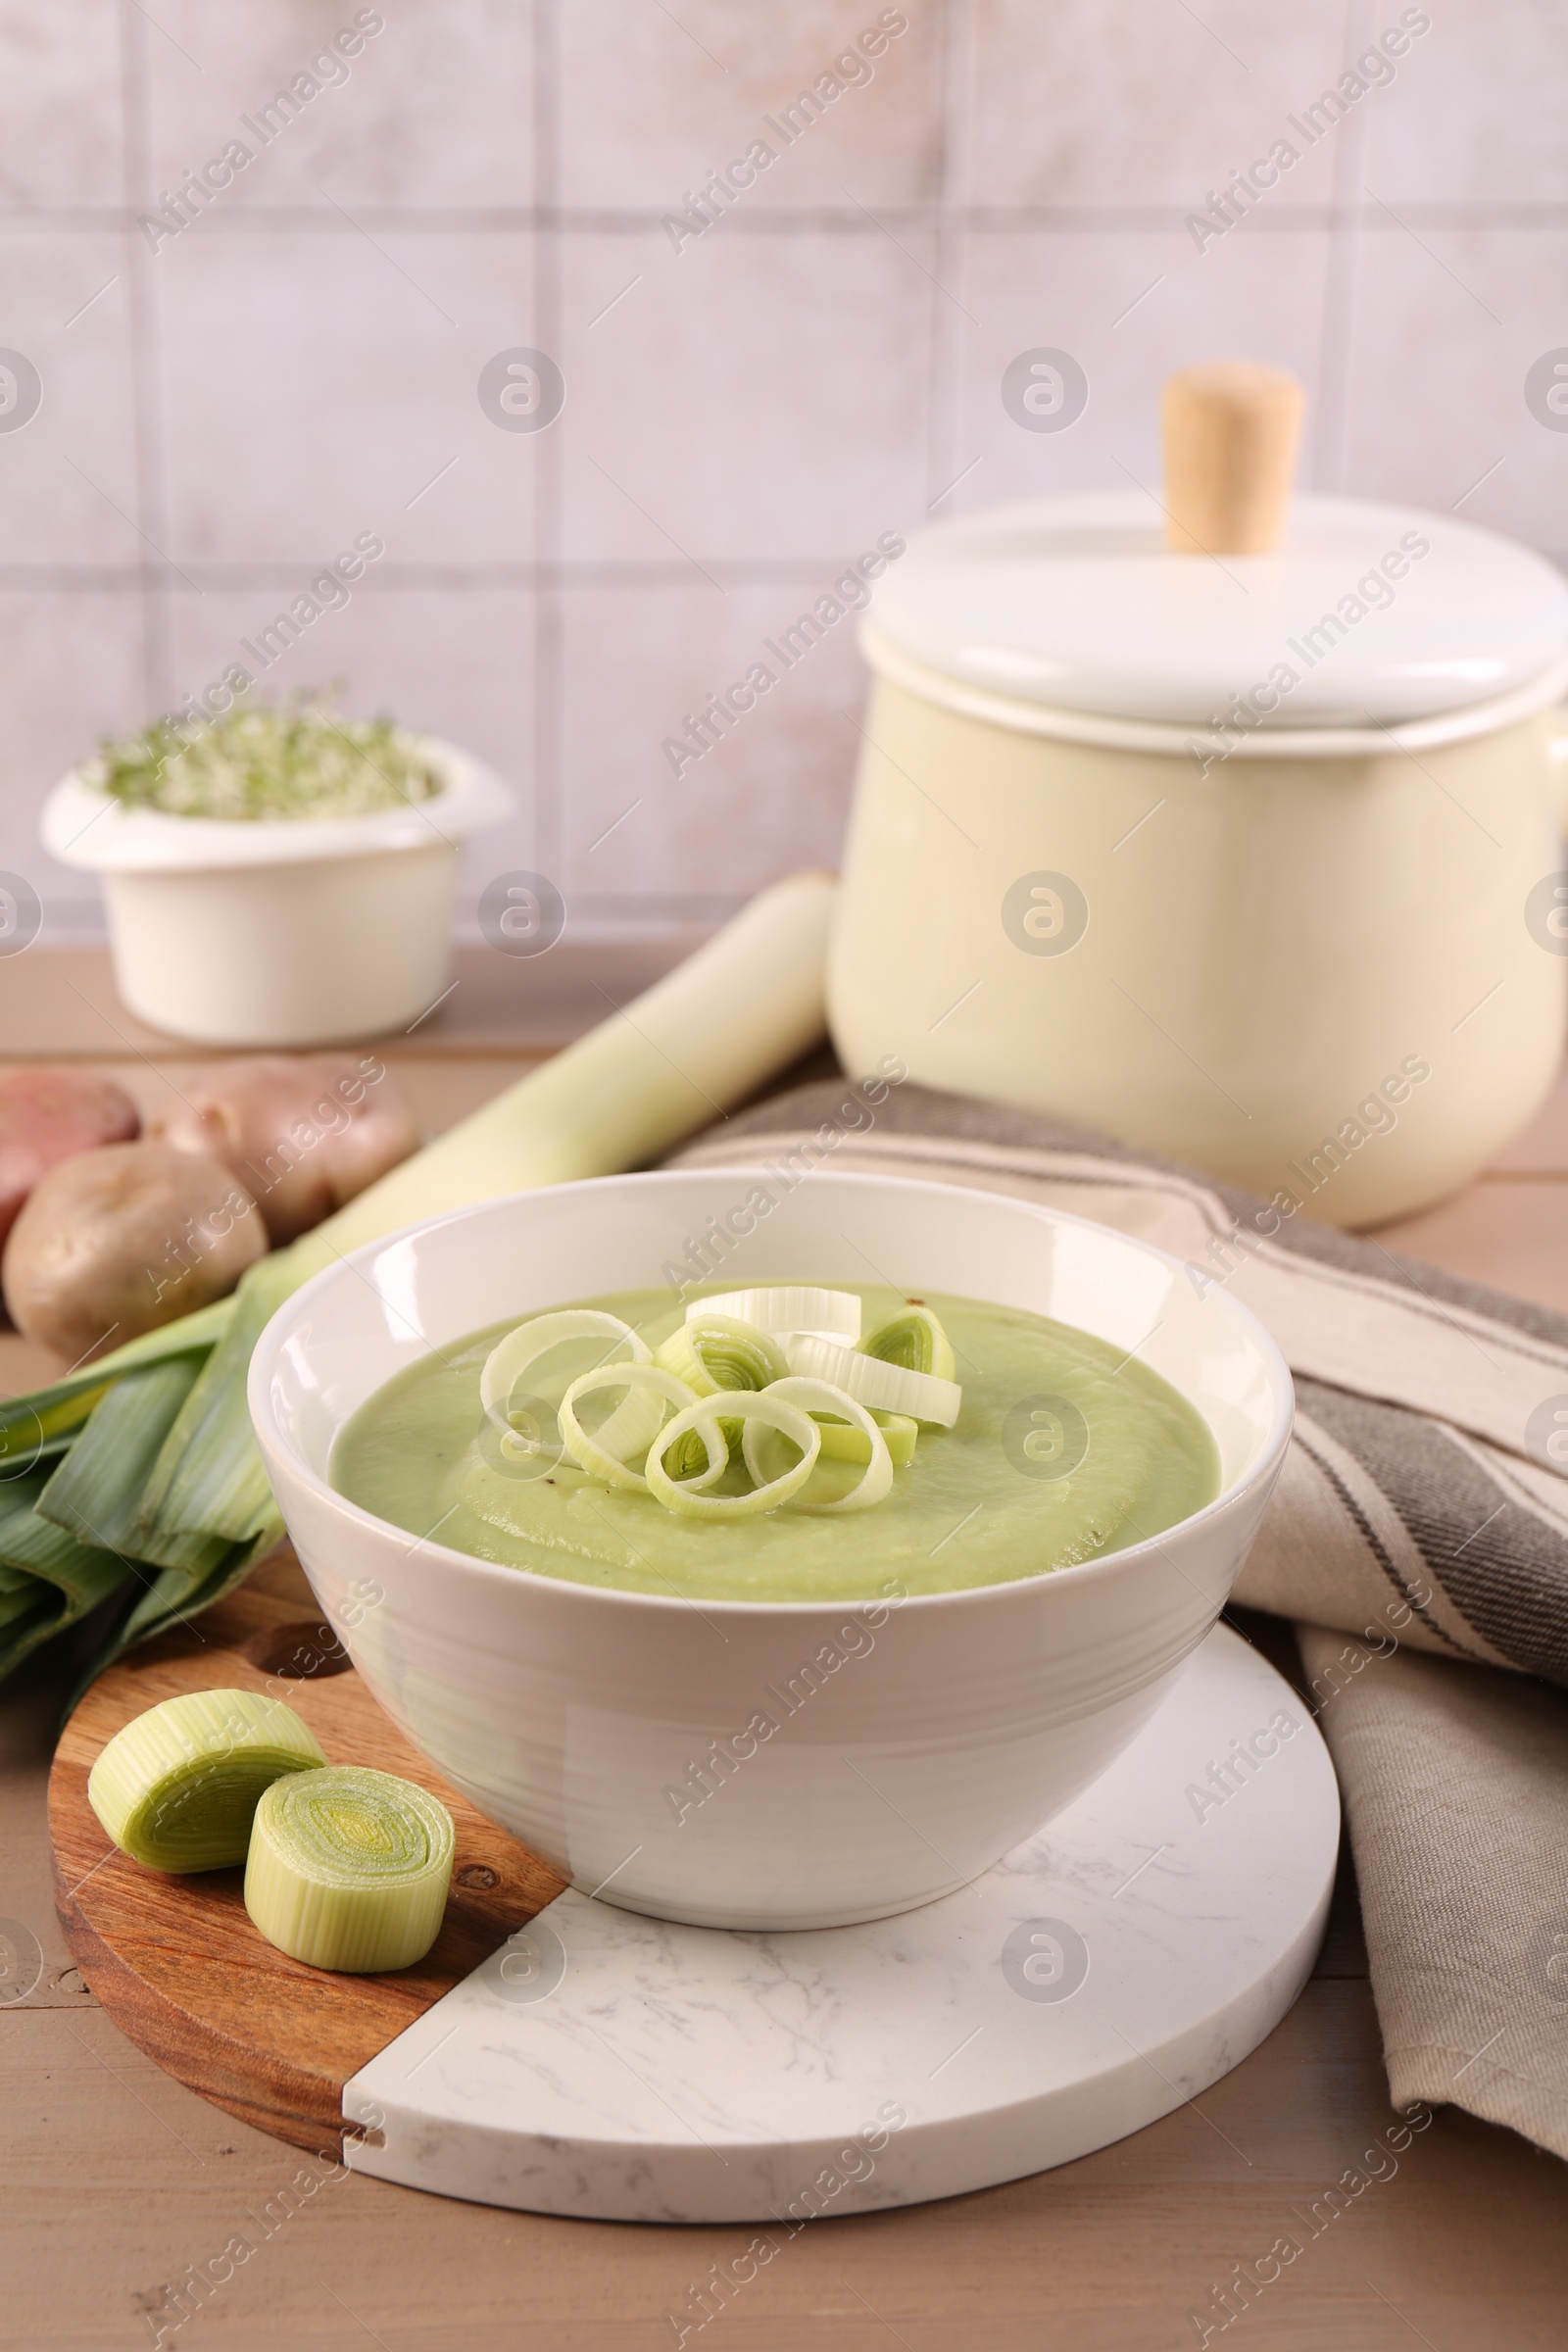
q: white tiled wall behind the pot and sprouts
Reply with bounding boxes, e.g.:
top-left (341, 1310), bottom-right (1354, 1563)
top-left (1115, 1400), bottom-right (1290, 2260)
top-left (0, 0), bottom-right (1568, 936)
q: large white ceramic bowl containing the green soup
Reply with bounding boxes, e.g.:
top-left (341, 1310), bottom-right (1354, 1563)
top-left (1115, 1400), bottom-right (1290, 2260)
top-left (249, 1169), bottom-right (1293, 1929)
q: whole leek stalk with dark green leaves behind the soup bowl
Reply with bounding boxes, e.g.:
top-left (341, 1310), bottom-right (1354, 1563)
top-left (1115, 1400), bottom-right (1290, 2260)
top-left (0, 872), bottom-right (835, 1680)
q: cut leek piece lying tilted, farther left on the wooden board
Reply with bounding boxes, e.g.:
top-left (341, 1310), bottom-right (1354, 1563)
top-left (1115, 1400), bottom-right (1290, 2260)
top-left (87, 1691), bottom-right (326, 1872)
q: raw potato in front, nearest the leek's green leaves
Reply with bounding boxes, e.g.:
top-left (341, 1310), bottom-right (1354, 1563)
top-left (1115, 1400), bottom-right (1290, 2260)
top-left (2, 1139), bottom-right (268, 1364)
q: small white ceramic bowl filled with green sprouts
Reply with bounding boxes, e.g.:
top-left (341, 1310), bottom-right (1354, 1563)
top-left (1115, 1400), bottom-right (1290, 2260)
top-left (40, 736), bottom-right (511, 1047)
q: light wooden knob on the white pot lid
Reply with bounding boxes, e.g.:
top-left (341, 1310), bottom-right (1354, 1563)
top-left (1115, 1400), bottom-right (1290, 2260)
top-left (1163, 360), bottom-right (1307, 555)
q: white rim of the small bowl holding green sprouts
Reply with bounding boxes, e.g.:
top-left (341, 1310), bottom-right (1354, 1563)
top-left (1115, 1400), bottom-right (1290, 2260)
top-left (37, 734), bottom-right (513, 875)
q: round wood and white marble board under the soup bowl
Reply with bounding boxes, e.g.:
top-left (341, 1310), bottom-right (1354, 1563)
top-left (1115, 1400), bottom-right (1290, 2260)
top-left (49, 1564), bottom-right (1340, 2220)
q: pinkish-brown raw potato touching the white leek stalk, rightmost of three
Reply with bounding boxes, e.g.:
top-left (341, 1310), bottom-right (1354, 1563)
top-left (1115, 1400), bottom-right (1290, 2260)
top-left (151, 1054), bottom-right (418, 1247)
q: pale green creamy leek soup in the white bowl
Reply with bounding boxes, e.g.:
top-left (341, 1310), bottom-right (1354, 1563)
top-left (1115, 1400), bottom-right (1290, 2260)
top-left (331, 1284), bottom-right (1220, 1601)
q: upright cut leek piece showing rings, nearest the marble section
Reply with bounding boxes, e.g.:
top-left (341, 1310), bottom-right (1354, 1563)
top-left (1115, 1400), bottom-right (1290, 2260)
top-left (244, 1764), bottom-right (454, 1974)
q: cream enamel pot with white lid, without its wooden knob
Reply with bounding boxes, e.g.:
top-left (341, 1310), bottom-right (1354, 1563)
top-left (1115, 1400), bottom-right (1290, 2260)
top-left (830, 492), bottom-right (1568, 1225)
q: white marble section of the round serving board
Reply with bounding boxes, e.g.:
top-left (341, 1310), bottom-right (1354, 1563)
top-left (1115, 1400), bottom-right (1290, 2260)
top-left (343, 1625), bottom-right (1340, 2232)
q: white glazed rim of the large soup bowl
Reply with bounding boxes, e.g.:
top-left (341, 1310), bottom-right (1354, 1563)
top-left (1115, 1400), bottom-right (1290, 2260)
top-left (247, 1166), bottom-right (1296, 1623)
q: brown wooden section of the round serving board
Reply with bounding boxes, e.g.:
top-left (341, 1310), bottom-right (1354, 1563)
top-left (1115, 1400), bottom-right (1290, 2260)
top-left (49, 1552), bottom-right (564, 2150)
